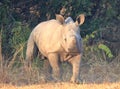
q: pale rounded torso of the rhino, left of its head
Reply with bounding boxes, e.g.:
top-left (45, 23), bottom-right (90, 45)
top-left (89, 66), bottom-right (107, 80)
top-left (32, 20), bottom-right (63, 56)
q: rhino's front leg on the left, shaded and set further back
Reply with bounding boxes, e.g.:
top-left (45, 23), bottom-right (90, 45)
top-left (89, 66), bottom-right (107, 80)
top-left (48, 53), bottom-right (61, 81)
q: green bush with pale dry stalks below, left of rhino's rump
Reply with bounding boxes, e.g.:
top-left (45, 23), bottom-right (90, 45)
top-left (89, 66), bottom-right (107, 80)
top-left (9, 22), bottom-right (30, 66)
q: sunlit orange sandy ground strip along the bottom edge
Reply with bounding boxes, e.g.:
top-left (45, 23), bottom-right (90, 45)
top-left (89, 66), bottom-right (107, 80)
top-left (0, 82), bottom-right (120, 89)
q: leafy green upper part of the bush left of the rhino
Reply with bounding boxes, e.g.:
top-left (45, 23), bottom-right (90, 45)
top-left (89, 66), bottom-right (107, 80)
top-left (10, 22), bottom-right (30, 49)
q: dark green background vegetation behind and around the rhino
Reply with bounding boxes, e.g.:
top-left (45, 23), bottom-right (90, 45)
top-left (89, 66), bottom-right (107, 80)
top-left (0, 0), bottom-right (120, 85)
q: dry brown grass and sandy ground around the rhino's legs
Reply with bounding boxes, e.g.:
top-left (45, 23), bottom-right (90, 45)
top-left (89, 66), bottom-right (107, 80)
top-left (0, 53), bottom-right (120, 89)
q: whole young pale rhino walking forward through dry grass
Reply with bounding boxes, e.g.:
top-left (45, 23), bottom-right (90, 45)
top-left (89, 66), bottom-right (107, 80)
top-left (26, 14), bottom-right (85, 83)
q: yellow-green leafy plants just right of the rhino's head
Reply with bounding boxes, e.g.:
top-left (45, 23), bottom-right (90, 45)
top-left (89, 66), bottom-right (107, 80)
top-left (83, 31), bottom-right (113, 61)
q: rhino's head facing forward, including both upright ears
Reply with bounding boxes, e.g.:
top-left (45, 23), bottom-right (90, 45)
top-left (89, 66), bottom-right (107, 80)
top-left (56, 14), bottom-right (85, 53)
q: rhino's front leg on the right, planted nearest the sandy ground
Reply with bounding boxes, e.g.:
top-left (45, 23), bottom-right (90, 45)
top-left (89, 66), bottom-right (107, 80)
top-left (69, 55), bottom-right (81, 83)
